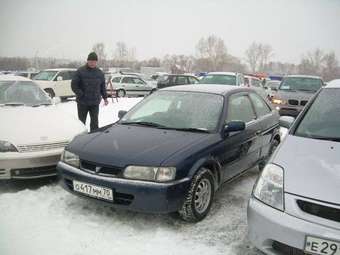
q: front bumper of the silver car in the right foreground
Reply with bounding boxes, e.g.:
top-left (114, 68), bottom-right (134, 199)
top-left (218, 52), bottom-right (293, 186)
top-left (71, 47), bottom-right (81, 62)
top-left (248, 197), bottom-right (340, 255)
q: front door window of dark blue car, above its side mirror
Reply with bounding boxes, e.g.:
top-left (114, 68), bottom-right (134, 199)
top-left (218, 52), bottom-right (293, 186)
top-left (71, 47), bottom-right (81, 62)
top-left (226, 94), bottom-right (256, 123)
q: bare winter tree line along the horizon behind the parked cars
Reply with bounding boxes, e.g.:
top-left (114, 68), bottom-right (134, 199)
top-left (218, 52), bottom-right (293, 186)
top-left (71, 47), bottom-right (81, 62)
top-left (0, 35), bottom-right (340, 81)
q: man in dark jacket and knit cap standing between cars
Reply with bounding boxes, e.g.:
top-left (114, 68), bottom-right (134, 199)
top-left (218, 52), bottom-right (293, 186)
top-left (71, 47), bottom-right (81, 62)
top-left (71, 52), bottom-right (109, 132)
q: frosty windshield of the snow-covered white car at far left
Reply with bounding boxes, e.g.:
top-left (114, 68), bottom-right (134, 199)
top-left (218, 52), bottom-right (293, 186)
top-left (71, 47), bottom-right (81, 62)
top-left (0, 81), bottom-right (51, 106)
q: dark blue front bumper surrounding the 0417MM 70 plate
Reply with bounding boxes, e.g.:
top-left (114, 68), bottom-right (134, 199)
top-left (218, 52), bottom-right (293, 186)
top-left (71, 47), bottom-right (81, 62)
top-left (57, 162), bottom-right (190, 213)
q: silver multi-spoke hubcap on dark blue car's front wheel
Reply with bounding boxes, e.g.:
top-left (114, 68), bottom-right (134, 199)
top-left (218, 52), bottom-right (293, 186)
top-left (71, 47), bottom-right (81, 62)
top-left (194, 178), bottom-right (212, 213)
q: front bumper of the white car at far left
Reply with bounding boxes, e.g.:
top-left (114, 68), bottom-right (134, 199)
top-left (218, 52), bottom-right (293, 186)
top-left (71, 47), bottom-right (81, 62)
top-left (0, 148), bottom-right (63, 179)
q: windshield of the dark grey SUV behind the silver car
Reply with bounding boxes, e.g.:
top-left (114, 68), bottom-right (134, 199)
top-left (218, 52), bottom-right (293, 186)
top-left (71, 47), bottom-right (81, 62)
top-left (279, 77), bottom-right (322, 92)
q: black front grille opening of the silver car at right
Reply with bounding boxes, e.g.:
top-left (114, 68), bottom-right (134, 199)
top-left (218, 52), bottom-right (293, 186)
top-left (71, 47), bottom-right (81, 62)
top-left (297, 200), bottom-right (340, 222)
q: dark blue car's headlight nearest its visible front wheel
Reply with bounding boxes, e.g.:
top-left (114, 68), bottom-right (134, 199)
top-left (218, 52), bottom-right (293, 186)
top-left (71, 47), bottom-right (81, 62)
top-left (124, 166), bottom-right (176, 182)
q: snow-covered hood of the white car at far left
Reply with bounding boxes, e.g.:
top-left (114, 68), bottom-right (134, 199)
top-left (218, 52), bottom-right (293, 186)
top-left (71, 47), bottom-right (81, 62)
top-left (0, 105), bottom-right (86, 145)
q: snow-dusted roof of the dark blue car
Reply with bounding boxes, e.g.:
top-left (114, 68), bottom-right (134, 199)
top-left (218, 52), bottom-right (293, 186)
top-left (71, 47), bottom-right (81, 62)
top-left (161, 84), bottom-right (254, 95)
